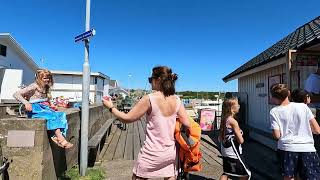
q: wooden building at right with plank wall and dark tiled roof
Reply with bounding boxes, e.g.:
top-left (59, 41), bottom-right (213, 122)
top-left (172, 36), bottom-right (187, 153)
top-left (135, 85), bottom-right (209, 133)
top-left (223, 17), bottom-right (320, 148)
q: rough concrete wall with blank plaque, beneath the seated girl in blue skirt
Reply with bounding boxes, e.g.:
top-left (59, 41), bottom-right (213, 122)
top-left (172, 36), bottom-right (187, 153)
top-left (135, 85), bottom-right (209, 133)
top-left (0, 106), bottom-right (111, 180)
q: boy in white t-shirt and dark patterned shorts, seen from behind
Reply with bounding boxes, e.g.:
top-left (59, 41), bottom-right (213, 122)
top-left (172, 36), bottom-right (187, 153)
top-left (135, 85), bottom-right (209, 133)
top-left (270, 84), bottom-right (320, 180)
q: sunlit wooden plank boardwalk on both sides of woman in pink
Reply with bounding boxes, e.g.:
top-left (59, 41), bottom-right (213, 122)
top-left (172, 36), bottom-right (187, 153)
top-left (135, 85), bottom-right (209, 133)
top-left (103, 119), bottom-right (222, 165)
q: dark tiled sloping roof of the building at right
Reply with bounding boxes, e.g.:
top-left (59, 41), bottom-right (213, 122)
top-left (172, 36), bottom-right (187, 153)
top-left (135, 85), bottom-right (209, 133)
top-left (223, 16), bottom-right (320, 82)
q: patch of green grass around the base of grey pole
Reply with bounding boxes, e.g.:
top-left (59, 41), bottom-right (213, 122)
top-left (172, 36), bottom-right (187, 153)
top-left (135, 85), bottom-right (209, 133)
top-left (62, 166), bottom-right (105, 180)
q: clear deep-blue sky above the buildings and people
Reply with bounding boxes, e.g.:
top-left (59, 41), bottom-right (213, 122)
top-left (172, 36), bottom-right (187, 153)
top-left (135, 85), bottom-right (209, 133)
top-left (0, 0), bottom-right (320, 91)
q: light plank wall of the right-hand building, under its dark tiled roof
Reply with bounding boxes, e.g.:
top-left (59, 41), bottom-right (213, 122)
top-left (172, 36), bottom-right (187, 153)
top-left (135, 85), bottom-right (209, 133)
top-left (238, 53), bottom-right (317, 149)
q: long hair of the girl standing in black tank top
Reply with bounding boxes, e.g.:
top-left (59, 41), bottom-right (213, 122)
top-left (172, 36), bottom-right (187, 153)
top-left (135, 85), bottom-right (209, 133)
top-left (219, 97), bottom-right (238, 140)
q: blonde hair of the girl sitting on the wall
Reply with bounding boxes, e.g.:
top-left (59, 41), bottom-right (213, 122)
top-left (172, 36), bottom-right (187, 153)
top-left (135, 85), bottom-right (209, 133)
top-left (35, 69), bottom-right (53, 99)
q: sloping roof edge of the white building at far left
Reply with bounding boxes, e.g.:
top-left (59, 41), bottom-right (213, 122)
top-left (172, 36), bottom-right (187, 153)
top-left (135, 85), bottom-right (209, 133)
top-left (0, 33), bottom-right (39, 70)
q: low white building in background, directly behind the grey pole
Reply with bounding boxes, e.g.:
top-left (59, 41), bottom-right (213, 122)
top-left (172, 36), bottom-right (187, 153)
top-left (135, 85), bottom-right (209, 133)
top-left (51, 70), bottom-right (110, 103)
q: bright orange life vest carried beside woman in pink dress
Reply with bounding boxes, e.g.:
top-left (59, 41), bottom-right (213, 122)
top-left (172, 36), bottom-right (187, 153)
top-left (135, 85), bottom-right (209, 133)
top-left (174, 117), bottom-right (202, 172)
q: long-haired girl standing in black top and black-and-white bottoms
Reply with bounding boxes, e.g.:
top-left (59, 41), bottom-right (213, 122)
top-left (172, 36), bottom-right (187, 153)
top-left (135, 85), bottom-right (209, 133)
top-left (219, 97), bottom-right (251, 180)
